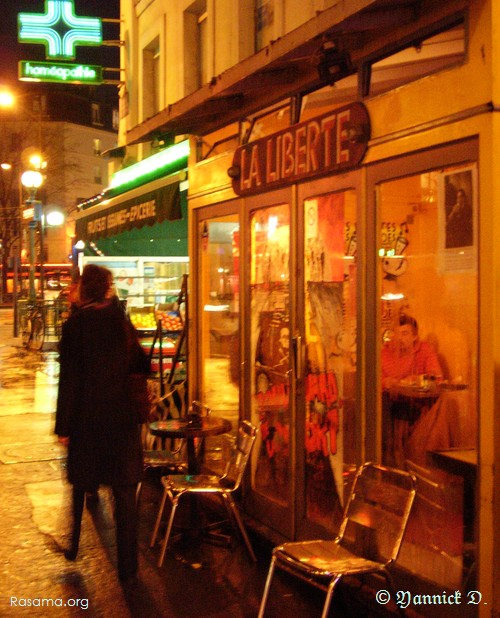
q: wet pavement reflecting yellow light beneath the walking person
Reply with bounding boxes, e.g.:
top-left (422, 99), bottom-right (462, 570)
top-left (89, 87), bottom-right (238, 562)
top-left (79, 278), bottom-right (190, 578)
top-left (0, 309), bottom-right (464, 618)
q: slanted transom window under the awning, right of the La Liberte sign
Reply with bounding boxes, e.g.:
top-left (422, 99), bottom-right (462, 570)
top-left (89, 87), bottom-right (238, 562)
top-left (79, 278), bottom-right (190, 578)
top-left (364, 21), bottom-right (466, 96)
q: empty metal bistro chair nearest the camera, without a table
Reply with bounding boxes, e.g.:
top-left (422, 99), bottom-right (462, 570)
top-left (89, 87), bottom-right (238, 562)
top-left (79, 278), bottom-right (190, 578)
top-left (259, 463), bottom-right (415, 618)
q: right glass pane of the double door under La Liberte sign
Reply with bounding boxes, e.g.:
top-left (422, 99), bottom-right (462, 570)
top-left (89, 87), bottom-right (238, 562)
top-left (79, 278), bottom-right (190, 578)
top-left (303, 190), bottom-right (357, 529)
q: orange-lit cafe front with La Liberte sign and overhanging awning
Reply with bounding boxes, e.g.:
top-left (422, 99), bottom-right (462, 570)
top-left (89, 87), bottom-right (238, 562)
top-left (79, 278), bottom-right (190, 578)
top-left (122, 0), bottom-right (500, 616)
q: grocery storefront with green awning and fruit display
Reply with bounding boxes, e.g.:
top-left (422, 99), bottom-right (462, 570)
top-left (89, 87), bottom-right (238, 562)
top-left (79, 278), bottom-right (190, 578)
top-left (75, 148), bottom-right (189, 381)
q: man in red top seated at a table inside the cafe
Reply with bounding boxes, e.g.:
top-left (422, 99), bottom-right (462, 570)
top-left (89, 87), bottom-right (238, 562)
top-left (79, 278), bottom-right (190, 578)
top-left (382, 314), bottom-right (443, 465)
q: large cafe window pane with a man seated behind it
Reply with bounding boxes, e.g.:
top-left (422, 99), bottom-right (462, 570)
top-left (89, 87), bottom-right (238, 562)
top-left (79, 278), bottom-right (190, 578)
top-left (377, 165), bottom-right (478, 587)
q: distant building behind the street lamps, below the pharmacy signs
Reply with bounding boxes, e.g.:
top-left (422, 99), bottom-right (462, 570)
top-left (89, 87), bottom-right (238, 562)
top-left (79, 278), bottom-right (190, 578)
top-left (0, 84), bottom-right (118, 292)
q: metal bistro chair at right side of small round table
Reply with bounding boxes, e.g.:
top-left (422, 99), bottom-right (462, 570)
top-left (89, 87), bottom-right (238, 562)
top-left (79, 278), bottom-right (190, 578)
top-left (150, 421), bottom-right (257, 567)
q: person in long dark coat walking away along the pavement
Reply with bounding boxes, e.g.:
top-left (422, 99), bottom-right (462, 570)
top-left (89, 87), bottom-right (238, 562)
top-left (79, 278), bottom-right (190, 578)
top-left (55, 265), bottom-right (148, 580)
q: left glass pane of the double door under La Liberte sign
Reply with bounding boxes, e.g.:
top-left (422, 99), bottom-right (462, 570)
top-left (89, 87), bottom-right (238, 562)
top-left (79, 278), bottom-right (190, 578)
top-left (247, 192), bottom-right (294, 537)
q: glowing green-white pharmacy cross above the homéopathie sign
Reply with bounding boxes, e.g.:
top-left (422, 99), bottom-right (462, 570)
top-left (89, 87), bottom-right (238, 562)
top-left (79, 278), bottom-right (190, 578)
top-left (18, 0), bottom-right (102, 59)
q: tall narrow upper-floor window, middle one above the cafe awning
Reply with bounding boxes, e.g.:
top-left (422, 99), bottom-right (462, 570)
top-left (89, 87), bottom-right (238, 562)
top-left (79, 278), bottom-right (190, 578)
top-left (184, 0), bottom-right (210, 95)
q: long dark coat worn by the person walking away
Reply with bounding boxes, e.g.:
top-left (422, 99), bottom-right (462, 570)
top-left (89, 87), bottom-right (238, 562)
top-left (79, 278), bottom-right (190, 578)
top-left (55, 301), bottom-right (147, 489)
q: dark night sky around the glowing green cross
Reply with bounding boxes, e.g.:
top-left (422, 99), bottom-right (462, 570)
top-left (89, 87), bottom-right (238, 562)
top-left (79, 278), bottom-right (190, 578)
top-left (0, 0), bottom-right (120, 85)
